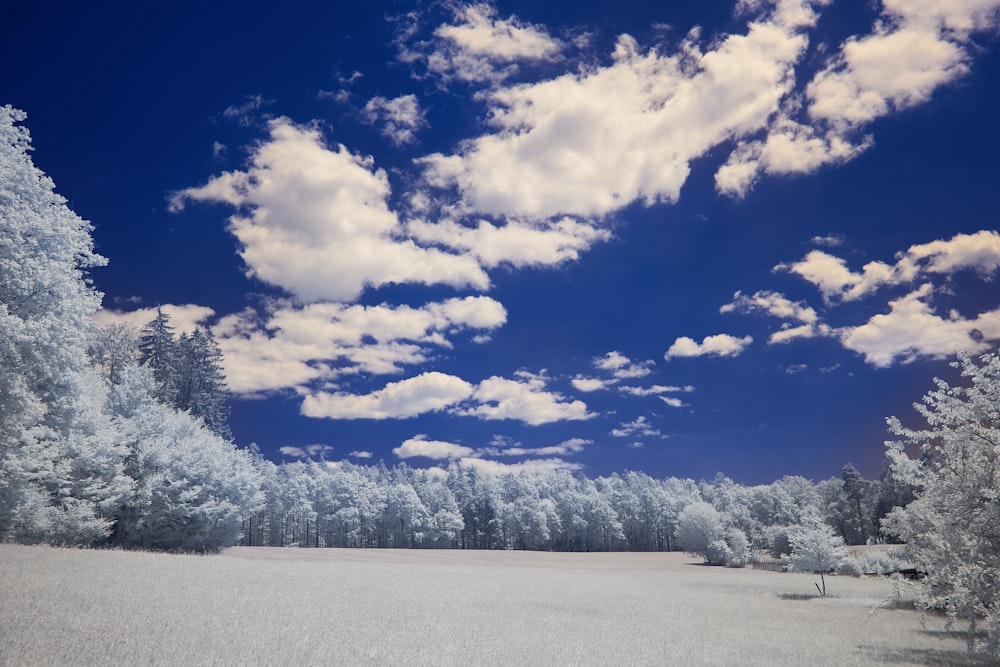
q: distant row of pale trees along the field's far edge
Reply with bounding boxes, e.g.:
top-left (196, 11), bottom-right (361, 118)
top-left (241, 456), bottom-right (916, 565)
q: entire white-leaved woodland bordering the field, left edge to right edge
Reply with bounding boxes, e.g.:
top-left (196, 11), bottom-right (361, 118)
top-left (0, 106), bottom-right (1000, 655)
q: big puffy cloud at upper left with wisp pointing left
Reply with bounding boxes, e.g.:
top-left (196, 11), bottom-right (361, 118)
top-left (171, 118), bottom-right (489, 301)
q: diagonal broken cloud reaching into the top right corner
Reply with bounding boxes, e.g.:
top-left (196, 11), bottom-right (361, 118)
top-left (716, 0), bottom-right (1000, 197)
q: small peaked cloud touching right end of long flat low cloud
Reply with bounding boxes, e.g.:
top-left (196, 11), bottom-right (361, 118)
top-left (460, 371), bottom-right (594, 426)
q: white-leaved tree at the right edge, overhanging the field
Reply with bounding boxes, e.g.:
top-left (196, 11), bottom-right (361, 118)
top-left (884, 353), bottom-right (1000, 658)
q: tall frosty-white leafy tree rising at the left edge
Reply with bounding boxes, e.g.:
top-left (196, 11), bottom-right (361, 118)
top-left (0, 106), bottom-right (127, 544)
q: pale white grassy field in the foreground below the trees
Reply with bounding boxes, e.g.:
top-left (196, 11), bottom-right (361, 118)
top-left (0, 545), bottom-right (984, 666)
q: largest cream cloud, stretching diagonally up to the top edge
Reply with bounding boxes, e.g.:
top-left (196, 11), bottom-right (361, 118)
top-left (424, 0), bottom-right (815, 219)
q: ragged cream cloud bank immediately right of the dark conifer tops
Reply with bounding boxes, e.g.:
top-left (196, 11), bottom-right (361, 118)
top-left (213, 296), bottom-right (507, 394)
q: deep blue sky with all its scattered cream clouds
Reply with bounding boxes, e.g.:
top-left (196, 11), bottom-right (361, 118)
top-left (0, 0), bottom-right (1000, 483)
